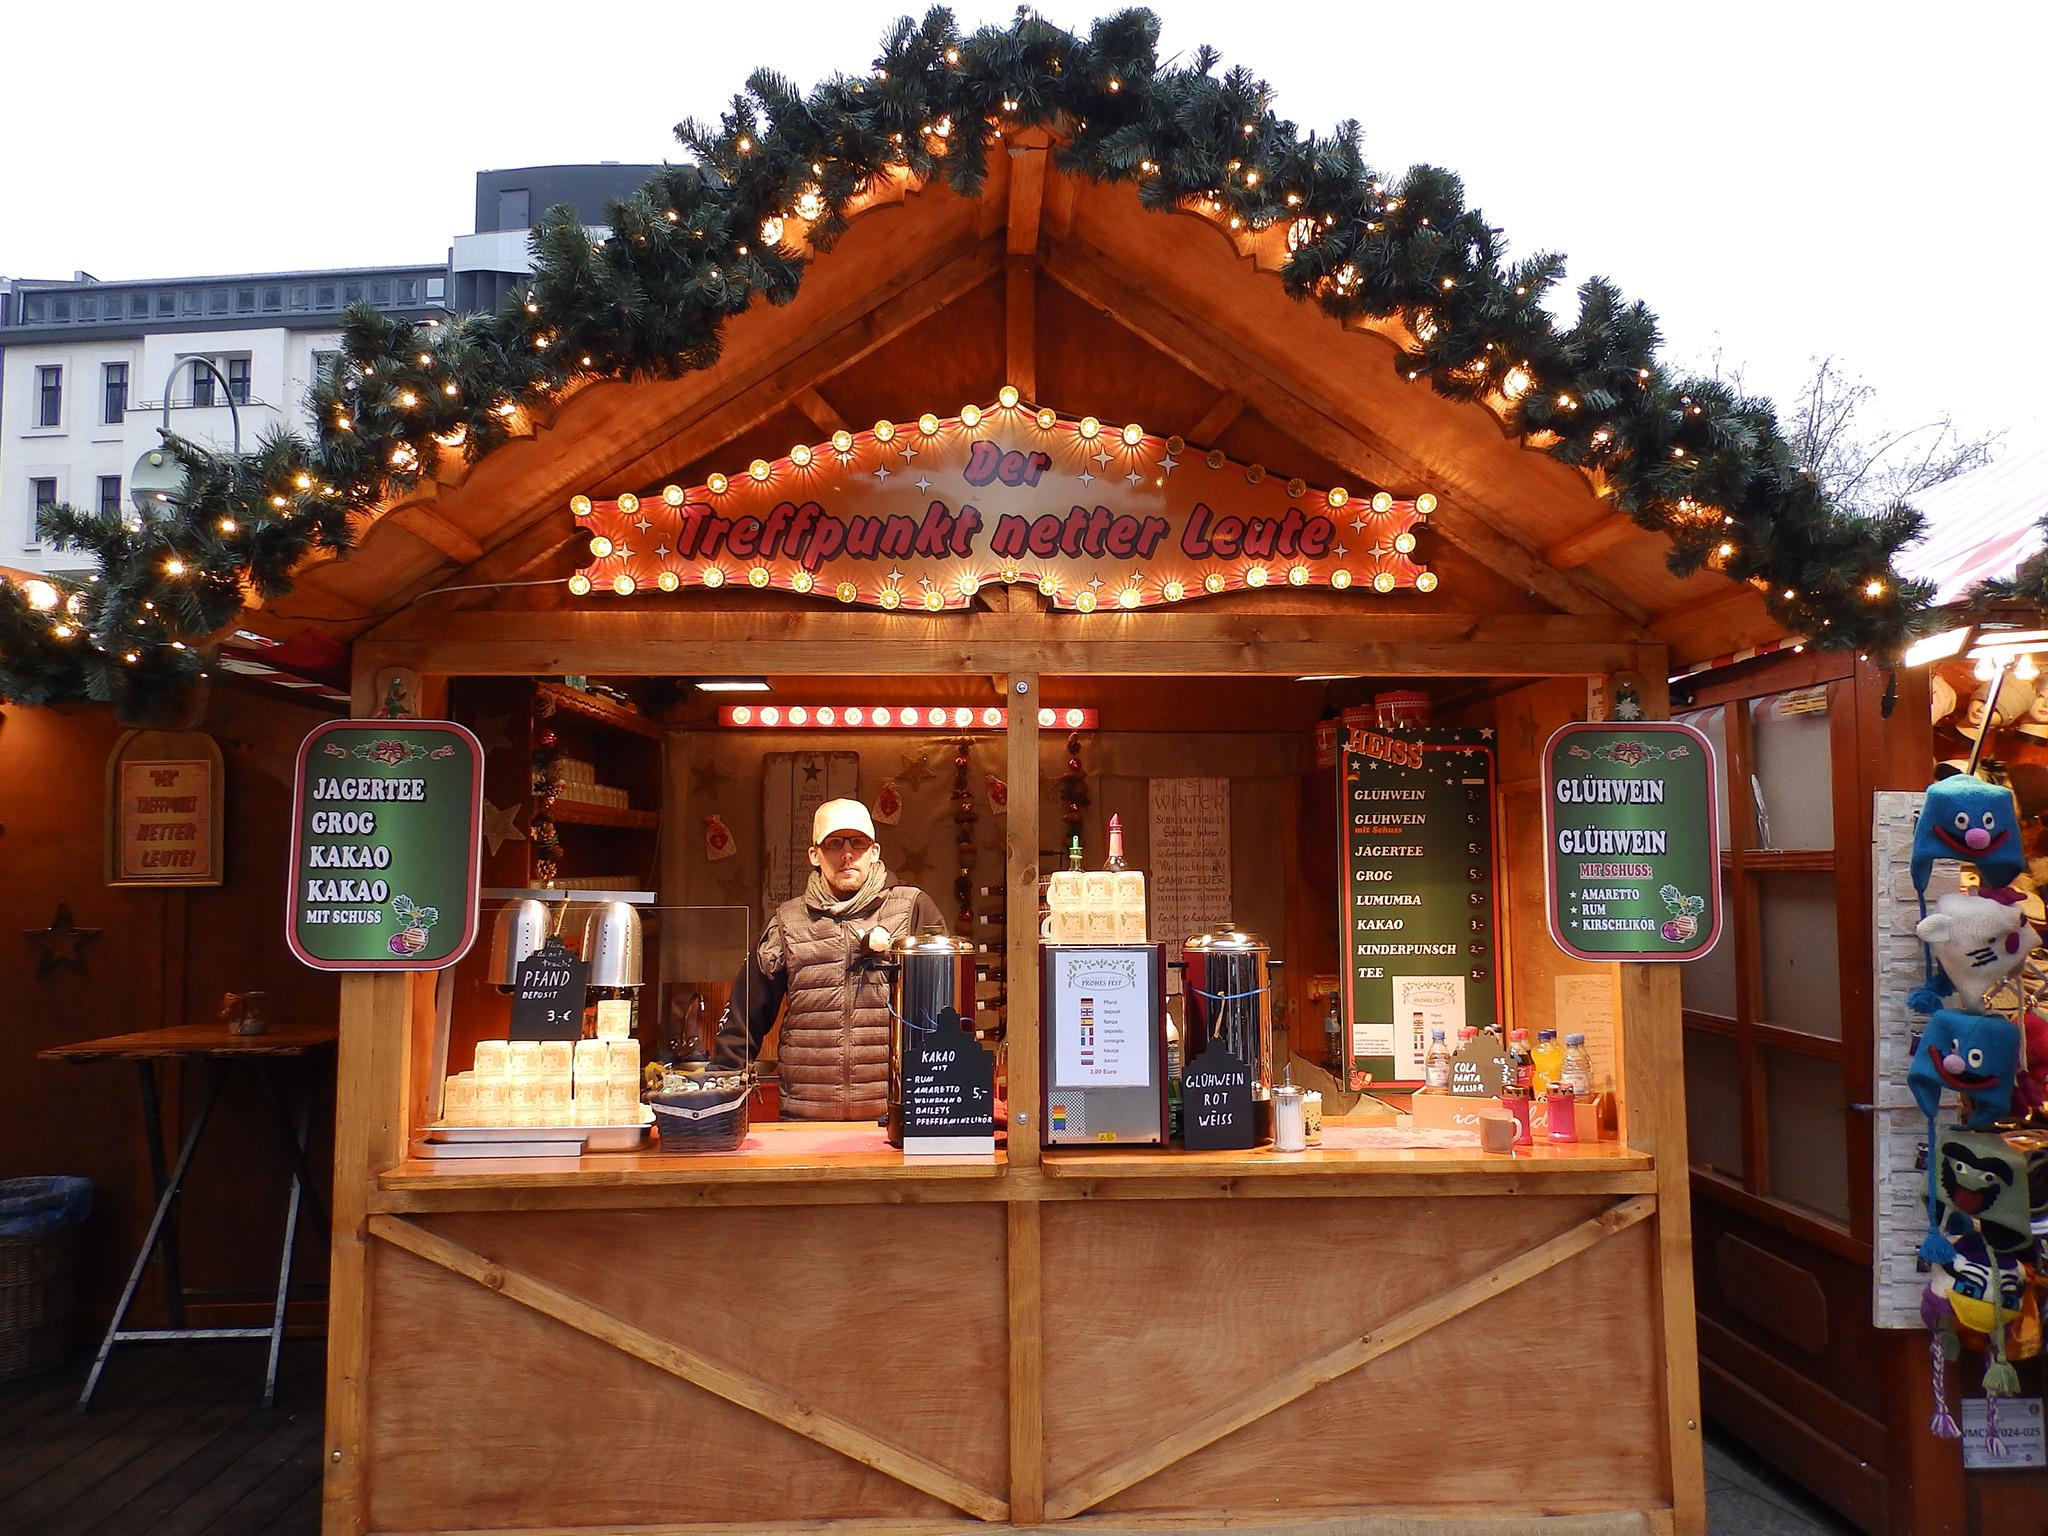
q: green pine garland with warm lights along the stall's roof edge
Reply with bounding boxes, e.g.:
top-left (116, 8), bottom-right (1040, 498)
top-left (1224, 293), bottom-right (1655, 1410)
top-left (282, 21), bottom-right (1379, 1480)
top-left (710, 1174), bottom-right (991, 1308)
top-left (0, 8), bottom-right (1929, 715)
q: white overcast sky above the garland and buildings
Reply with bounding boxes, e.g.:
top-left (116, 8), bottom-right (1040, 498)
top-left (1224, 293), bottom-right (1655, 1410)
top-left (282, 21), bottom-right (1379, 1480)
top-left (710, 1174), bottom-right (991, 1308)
top-left (0, 0), bottom-right (2048, 454)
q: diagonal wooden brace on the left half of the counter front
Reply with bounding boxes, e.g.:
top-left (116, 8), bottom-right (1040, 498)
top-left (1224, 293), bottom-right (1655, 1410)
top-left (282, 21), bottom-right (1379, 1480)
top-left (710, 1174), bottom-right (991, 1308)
top-left (369, 1217), bottom-right (1010, 1520)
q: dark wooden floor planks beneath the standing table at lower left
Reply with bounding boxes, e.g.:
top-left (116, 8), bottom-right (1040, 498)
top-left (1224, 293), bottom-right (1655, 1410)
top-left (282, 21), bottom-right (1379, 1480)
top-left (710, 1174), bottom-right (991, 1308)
top-left (0, 1339), bottom-right (326, 1536)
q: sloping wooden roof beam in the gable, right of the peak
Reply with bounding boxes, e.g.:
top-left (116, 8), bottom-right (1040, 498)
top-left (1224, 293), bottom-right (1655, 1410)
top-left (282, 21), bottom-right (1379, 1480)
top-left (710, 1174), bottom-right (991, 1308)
top-left (1044, 242), bottom-right (1649, 625)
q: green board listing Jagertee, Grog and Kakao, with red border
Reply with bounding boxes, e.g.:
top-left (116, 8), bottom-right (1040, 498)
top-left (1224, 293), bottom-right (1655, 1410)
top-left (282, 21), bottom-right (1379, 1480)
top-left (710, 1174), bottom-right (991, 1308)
top-left (285, 721), bottom-right (483, 971)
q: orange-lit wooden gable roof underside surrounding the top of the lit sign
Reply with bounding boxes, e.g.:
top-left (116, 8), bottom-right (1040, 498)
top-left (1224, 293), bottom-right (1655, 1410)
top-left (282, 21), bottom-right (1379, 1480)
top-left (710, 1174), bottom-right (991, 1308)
top-left (268, 143), bottom-right (1782, 664)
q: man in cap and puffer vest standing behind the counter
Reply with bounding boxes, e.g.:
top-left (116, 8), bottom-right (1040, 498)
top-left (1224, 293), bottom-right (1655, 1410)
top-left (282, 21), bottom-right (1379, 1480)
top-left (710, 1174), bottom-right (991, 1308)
top-left (719, 801), bottom-right (946, 1120)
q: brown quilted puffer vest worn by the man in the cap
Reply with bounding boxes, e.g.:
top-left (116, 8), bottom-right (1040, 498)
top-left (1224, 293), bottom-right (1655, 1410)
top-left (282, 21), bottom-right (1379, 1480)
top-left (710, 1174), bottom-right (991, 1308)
top-left (776, 885), bottom-right (922, 1120)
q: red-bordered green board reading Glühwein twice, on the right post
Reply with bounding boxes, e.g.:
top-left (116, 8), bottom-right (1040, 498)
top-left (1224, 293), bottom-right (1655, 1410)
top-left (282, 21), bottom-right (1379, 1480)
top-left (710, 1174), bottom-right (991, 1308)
top-left (1542, 721), bottom-right (1720, 961)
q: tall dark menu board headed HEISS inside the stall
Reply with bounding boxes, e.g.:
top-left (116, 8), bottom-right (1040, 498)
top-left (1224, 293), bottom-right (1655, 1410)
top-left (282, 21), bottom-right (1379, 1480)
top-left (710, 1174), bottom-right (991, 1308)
top-left (1337, 727), bottom-right (1499, 1087)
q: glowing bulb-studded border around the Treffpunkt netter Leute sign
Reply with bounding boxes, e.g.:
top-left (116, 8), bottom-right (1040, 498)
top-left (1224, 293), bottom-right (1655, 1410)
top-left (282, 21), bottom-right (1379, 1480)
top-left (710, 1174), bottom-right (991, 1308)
top-left (569, 397), bottom-right (1438, 614)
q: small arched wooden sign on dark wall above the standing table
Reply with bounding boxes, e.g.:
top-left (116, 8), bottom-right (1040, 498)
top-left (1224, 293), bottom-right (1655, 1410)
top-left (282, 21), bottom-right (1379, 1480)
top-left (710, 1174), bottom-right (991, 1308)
top-left (106, 731), bottom-right (225, 885)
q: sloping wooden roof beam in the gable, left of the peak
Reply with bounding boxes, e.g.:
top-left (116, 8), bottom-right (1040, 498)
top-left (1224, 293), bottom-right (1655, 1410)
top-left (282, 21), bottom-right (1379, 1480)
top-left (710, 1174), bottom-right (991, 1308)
top-left (362, 238), bottom-right (1001, 638)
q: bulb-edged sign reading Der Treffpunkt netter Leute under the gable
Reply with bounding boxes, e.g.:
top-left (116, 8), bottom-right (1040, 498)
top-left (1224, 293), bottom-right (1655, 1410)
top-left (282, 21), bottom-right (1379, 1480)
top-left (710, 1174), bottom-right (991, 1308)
top-left (569, 403), bottom-right (1436, 612)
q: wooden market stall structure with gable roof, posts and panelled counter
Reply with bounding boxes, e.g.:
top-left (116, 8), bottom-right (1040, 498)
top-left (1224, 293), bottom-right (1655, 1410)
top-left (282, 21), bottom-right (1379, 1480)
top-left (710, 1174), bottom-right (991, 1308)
top-left (250, 117), bottom-right (1826, 1534)
